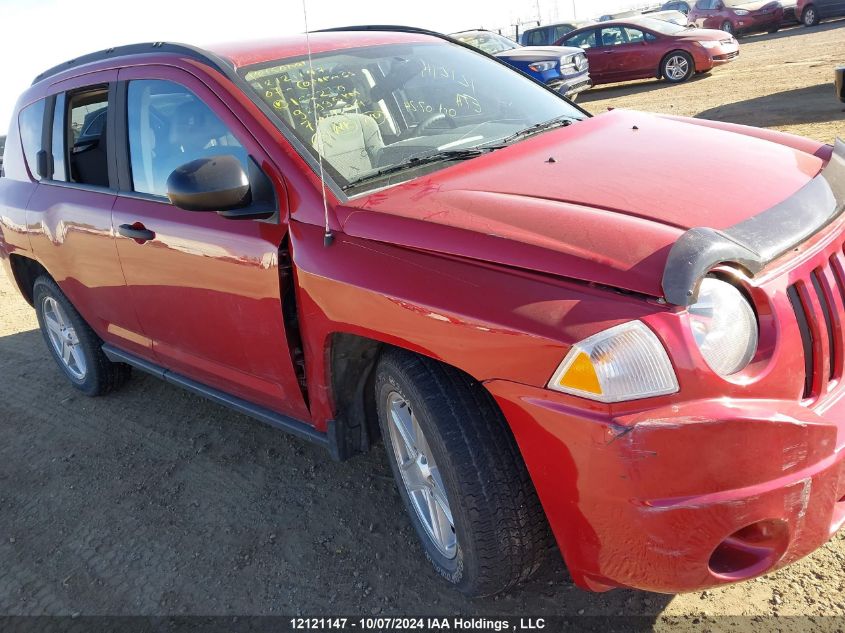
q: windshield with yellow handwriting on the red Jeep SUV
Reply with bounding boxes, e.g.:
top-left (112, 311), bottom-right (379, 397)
top-left (242, 41), bottom-right (586, 194)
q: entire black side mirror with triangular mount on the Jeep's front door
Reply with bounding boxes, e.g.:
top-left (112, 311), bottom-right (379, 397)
top-left (167, 154), bottom-right (278, 220)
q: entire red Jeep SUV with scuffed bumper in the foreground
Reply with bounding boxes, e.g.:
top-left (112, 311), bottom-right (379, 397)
top-left (0, 27), bottom-right (845, 594)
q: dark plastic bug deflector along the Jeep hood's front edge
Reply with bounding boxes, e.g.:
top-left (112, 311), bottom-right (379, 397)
top-left (663, 140), bottom-right (845, 306)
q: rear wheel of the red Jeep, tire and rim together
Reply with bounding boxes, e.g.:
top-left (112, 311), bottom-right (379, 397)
top-left (32, 275), bottom-right (131, 396)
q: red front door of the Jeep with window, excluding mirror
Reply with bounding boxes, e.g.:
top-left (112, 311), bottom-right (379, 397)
top-left (112, 66), bottom-right (309, 420)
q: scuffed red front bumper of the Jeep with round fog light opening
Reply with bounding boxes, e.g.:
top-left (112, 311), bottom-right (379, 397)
top-left (487, 381), bottom-right (845, 593)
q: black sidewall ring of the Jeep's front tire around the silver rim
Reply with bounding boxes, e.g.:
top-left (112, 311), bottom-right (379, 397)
top-left (375, 363), bottom-right (472, 588)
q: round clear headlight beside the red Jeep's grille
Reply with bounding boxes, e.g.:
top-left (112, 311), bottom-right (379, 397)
top-left (688, 277), bottom-right (758, 376)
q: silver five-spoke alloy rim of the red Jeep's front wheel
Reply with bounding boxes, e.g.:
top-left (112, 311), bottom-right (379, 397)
top-left (387, 391), bottom-right (458, 560)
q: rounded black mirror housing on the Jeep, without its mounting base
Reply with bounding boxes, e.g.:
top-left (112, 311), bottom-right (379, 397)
top-left (167, 154), bottom-right (252, 211)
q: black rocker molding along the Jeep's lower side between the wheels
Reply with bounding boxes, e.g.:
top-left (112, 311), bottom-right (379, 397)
top-left (102, 343), bottom-right (350, 461)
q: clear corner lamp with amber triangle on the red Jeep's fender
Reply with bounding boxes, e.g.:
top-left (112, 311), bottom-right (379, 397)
top-left (549, 321), bottom-right (678, 402)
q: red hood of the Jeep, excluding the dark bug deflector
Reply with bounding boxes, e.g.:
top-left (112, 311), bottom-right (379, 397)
top-left (338, 110), bottom-right (824, 297)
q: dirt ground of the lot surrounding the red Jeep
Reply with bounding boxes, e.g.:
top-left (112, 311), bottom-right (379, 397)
top-left (0, 22), bottom-right (845, 630)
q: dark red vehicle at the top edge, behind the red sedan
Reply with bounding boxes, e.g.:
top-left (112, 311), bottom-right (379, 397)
top-left (687, 0), bottom-right (784, 35)
